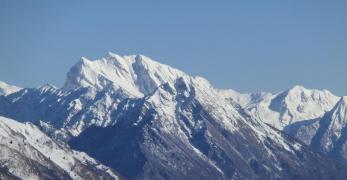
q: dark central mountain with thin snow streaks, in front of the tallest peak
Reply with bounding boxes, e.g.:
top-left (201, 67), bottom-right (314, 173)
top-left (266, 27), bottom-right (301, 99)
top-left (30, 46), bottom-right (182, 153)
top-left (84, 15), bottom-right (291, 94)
top-left (70, 78), bottom-right (347, 179)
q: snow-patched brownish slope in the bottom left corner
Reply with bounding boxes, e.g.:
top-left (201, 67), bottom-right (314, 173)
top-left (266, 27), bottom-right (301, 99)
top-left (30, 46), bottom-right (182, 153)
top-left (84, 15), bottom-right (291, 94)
top-left (0, 117), bottom-right (117, 179)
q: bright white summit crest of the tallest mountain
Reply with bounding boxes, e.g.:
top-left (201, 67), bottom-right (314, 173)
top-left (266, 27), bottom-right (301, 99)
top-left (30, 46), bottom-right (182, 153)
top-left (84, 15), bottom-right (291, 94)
top-left (63, 52), bottom-right (187, 97)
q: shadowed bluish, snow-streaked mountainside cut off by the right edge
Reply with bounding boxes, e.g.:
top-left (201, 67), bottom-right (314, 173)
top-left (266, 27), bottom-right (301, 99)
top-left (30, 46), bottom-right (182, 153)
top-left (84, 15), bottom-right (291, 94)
top-left (285, 97), bottom-right (347, 162)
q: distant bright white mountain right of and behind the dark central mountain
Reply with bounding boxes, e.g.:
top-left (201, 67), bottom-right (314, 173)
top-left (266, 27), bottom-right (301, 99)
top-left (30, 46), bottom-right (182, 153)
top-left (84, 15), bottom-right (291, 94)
top-left (221, 86), bottom-right (339, 129)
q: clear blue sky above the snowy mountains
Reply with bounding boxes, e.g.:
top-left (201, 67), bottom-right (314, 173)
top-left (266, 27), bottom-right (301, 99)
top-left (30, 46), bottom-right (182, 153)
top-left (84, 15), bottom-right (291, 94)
top-left (0, 0), bottom-right (347, 95)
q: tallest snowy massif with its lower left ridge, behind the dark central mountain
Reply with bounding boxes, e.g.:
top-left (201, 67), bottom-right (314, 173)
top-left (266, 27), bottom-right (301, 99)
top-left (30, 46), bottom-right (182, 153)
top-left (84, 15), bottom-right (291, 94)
top-left (0, 53), bottom-right (188, 135)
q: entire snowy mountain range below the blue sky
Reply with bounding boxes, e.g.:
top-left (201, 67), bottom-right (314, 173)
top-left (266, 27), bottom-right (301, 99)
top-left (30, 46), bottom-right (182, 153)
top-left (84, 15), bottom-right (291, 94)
top-left (0, 53), bottom-right (347, 180)
